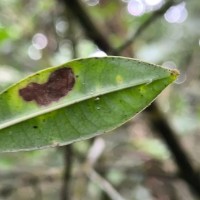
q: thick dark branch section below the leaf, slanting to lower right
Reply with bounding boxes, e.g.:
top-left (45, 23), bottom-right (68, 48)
top-left (146, 102), bottom-right (200, 196)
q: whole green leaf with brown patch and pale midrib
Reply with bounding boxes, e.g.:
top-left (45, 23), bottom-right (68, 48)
top-left (0, 57), bottom-right (178, 152)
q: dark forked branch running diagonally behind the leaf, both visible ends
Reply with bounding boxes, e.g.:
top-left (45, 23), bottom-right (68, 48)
top-left (59, 0), bottom-right (200, 196)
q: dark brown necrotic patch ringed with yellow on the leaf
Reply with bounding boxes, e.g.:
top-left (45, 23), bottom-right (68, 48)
top-left (19, 67), bottom-right (75, 106)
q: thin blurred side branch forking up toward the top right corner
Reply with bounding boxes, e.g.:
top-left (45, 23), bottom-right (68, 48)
top-left (113, 0), bottom-right (180, 55)
